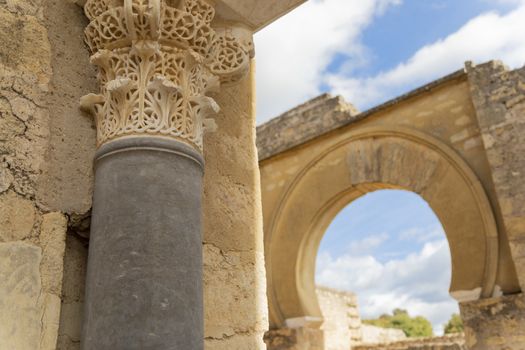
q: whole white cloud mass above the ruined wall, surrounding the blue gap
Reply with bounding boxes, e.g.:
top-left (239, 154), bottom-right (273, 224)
top-left (255, 0), bottom-right (525, 123)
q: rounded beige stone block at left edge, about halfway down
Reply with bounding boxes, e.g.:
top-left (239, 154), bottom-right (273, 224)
top-left (0, 192), bottom-right (36, 242)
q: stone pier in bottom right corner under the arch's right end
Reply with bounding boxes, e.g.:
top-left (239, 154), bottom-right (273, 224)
top-left (459, 294), bottom-right (525, 350)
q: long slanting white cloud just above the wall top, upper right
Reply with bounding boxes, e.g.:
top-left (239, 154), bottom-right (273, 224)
top-left (326, 1), bottom-right (525, 107)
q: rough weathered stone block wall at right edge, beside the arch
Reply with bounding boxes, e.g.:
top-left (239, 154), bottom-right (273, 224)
top-left (467, 62), bottom-right (525, 290)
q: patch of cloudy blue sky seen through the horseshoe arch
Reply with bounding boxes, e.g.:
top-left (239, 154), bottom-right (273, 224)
top-left (316, 190), bottom-right (452, 334)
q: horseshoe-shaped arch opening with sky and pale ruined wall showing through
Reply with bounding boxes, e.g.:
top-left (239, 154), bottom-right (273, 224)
top-left (315, 189), bottom-right (459, 349)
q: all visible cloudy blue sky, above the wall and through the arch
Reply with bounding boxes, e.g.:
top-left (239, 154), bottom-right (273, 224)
top-left (255, 0), bottom-right (525, 333)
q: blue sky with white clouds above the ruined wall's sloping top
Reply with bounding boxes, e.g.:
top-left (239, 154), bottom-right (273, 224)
top-left (255, 0), bottom-right (525, 123)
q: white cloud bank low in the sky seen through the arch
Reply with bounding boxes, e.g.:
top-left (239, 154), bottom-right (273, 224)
top-left (316, 239), bottom-right (458, 334)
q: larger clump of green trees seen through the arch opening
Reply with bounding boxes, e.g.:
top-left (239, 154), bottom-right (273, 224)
top-left (363, 309), bottom-right (434, 338)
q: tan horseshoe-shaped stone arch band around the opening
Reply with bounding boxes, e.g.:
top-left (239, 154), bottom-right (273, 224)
top-left (265, 127), bottom-right (498, 327)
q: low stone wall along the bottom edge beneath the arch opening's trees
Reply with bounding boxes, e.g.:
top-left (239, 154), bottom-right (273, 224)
top-left (352, 334), bottom-right (467, 350)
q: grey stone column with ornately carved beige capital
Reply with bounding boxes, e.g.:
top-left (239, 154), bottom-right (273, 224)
top-left (81, 0), bottom-right (253, 350)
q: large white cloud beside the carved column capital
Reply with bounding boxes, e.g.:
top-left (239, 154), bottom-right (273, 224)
top-left (255, 0), bottom-right (401, 122)
